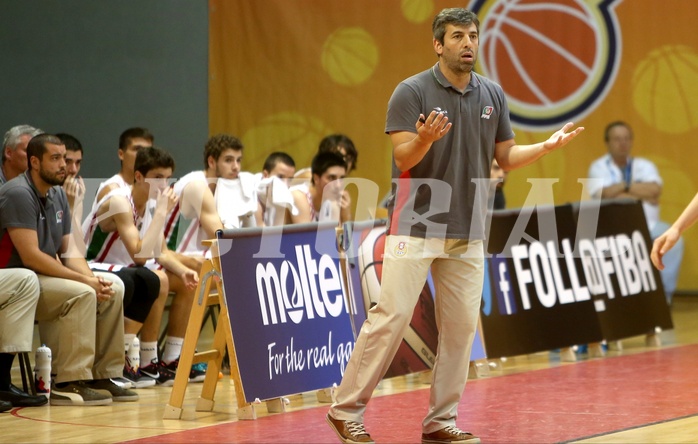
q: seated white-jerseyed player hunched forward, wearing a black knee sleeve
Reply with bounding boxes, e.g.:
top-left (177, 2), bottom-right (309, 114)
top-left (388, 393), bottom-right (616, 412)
top-left (83, 147), bottom-right (203, 386)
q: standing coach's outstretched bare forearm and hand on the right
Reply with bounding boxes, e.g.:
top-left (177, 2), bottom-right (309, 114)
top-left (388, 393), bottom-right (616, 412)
top-left (494, 122), bottom-right (584, 171)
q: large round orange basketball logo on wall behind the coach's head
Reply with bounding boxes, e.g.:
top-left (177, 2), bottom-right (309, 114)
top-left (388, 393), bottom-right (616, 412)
top-left (469, 0), bottom-right (621, 131)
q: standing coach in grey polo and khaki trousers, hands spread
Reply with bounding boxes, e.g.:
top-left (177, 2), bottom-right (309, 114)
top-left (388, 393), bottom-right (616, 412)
top-left (327, 8), bottom-right (583, 443)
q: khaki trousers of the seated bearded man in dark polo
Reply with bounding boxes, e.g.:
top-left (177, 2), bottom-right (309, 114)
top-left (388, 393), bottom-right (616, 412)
top-left (36, 271), bottom-right (124, 382)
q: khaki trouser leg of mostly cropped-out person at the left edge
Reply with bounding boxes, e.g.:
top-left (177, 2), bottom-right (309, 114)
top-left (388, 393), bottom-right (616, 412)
top-left (0, 268), bottom-right (39, 353)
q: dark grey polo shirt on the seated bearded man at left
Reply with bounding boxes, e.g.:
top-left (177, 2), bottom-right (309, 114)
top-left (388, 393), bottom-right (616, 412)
top-left (0, 171), bottom-right (70, 268)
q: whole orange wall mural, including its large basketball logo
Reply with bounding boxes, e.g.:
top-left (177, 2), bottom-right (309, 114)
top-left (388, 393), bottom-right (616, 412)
top-left (211, 0), bottom-right (698, 290)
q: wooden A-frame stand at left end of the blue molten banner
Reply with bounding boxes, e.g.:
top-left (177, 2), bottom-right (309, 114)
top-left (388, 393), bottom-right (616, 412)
top-left (163, 240), bottom-right (256, 419)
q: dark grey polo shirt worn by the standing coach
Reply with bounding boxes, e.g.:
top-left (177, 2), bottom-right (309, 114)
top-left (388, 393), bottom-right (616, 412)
top-left (385, 63), bottom-right (514, 240)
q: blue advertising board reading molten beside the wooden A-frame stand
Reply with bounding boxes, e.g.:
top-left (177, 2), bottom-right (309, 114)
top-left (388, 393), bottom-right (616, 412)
top-left (218, 224), bottom-right (365, 402)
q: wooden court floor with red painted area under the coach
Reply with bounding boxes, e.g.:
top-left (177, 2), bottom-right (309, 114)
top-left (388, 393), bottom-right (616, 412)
top-left (0, 296), bottom-right (698, 443)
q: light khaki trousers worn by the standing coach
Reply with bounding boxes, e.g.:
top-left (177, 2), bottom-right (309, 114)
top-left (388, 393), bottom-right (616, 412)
top-left (330, 236), bottom-right (484, 433)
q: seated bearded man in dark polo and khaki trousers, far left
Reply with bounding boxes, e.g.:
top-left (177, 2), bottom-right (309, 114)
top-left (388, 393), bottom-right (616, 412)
top-left (0, 134), bottom-right (138, 405)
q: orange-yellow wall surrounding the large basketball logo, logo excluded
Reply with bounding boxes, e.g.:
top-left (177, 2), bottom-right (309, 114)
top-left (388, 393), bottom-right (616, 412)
top-left (209, 0), bottom-right (698, 290)
